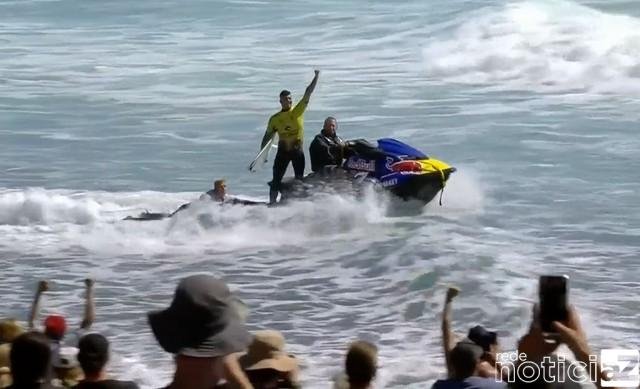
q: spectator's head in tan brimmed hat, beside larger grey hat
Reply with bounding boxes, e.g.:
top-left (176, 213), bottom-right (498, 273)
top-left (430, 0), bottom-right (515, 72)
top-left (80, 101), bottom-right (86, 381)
top-left (238, 330), bottom-right (298, 388)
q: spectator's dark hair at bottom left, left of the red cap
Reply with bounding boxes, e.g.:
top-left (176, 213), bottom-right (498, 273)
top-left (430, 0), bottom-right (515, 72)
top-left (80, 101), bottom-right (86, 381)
top-left (10, 331), bottom-right (51, 385)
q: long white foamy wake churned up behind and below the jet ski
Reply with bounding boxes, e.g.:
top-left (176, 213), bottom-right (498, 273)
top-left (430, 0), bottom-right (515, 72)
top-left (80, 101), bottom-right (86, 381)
top-left (0, 188), bottom-right (392, 255)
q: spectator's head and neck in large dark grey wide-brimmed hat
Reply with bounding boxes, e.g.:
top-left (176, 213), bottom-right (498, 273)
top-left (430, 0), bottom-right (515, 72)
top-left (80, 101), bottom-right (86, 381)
top-left (148, 274), bottom-right (251, 378)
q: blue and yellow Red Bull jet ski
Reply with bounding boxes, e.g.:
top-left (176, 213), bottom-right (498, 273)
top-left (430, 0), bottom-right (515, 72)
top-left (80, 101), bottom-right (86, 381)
top-left (280, 138), bottom-right (456, 205)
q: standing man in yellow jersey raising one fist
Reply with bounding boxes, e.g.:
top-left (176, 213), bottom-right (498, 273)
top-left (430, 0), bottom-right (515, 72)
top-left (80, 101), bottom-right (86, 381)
top-left (260, 70), bottom-right (320, 204)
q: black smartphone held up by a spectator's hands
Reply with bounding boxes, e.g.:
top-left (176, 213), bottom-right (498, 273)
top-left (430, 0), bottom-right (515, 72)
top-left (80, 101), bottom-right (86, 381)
top-left (538, 275), bottom-right (569, 334)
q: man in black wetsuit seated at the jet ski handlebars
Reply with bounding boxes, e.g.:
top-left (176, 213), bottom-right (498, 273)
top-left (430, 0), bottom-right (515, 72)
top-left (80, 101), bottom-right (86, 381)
top-left (309, 116), bottom-right (344, 173)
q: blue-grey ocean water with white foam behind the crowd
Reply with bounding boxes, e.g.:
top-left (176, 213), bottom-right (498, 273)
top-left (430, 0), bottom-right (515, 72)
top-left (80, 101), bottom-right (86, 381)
top-left (0, 0), bottom-right (640, 388)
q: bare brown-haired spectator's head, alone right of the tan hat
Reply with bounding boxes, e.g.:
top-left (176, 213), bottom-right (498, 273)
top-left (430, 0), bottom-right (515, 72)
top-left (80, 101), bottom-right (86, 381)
top-left (345, 340), bottom-right (378, 388)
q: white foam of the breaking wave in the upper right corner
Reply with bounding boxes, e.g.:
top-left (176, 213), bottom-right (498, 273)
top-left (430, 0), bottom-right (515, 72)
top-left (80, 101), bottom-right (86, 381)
top-left (423, 0), bottom-right (640, 96)
